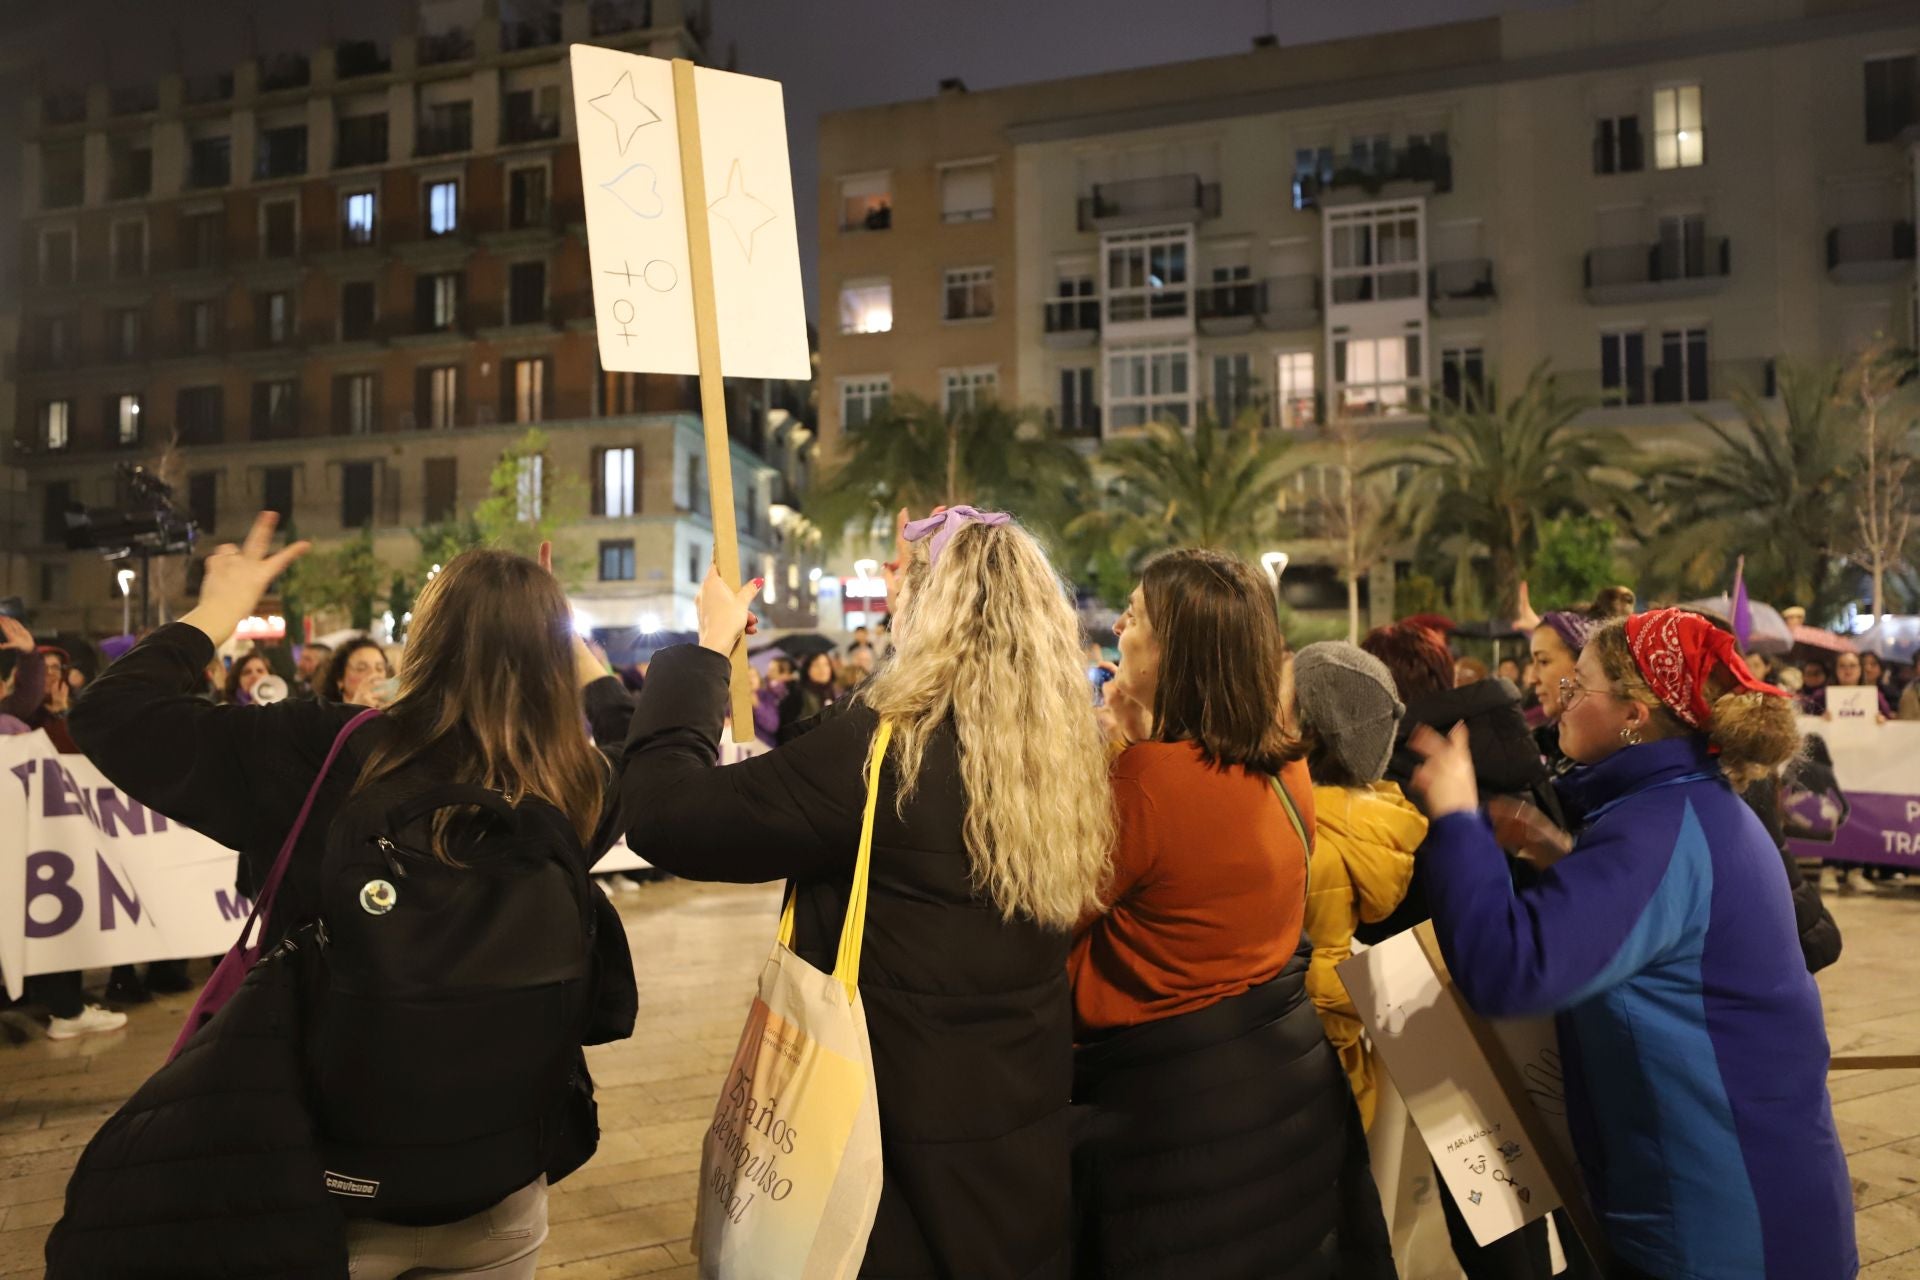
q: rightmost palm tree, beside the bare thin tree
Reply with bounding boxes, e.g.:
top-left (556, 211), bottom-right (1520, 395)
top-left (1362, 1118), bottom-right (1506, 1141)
top-left (1647, 365), bottom-right (1860, 620)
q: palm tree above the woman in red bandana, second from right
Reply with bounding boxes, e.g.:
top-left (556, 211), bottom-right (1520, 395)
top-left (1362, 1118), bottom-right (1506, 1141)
top-left (1369, 365), bottom-right (1636, 608)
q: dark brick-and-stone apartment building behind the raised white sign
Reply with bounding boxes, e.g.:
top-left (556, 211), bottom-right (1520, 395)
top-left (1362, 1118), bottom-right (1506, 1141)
top-left (13, 0), bottom-right (810, 629)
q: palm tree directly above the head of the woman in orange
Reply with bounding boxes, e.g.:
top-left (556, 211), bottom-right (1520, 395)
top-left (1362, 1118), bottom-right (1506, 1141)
top-left (1068, 411), bottom-right (1298, 568)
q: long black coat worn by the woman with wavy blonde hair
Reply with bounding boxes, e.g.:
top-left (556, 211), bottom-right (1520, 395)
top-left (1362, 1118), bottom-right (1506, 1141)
top-left (622, 647), bottom-right (1073, 1280)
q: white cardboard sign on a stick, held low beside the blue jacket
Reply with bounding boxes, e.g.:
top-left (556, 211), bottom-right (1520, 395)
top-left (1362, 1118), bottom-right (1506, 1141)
top-left (1338, 925), bottom-right (1599, 1249)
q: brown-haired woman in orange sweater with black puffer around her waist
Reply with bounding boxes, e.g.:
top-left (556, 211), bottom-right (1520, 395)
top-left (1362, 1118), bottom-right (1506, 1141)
top-left (1071, 551), bottom-right (1394, 1280)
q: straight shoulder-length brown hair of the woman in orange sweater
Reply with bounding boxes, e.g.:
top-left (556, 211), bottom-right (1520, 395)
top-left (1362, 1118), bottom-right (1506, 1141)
top-left (1140, 547), bottom-right (1306, 773)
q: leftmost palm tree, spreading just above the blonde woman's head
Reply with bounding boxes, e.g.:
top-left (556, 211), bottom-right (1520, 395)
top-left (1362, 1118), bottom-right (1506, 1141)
top-left (808, 395), bottom-right (1087, 537)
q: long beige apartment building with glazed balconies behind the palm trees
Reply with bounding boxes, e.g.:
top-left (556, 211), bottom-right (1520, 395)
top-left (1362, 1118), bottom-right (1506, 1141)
top-left (820, 0), bottom-right (1920, 606)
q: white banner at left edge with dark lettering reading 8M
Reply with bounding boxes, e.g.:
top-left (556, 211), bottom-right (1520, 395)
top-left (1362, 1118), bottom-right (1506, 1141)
top-left (0, 733), bottom-right (253, 998)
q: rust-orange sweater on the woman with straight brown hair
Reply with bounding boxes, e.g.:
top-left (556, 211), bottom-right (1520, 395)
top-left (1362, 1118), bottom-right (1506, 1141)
top-left (1068, 743), bottom-right (1313, 1036)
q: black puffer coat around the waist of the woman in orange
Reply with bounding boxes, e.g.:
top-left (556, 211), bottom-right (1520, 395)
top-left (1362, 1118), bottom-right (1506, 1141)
top-left (1073, 942), bottom-right (1394, 1280)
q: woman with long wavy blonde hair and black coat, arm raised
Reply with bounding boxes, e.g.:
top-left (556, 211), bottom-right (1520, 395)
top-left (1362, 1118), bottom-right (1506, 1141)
top-left (622, 507), bottom-right (1114, 1280)
